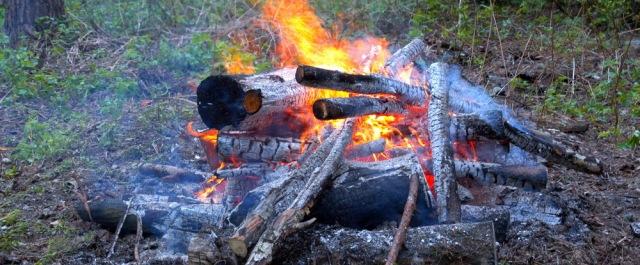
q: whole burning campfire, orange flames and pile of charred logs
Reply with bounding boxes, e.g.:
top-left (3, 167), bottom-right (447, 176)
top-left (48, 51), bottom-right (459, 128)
top-left (80, 1), bottom-right (602, 264)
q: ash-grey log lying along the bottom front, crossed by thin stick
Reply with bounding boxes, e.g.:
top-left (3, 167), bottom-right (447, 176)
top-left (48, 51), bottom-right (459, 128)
top-left (274, 222), bottom-right (497, 264)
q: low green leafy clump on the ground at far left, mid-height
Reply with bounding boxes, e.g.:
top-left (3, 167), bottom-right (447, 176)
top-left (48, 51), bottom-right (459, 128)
top-left (13, 117), bottom-right (76, 163)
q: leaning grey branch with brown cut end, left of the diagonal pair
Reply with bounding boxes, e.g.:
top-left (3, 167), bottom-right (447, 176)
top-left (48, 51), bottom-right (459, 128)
top-left (228, 122), bottom-right (348, 257)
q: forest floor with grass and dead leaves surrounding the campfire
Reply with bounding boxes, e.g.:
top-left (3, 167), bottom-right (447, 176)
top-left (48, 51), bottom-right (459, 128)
top-left (0, 1), bottom-right (640, 264)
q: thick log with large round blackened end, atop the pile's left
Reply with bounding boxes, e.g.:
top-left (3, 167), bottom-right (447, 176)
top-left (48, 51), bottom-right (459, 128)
top-left (197, 68), bottom-right (319, 131)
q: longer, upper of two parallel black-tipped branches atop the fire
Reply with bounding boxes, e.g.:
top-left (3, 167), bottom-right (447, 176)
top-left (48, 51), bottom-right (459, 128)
top-left (296, 65), bottom-right (428, 105)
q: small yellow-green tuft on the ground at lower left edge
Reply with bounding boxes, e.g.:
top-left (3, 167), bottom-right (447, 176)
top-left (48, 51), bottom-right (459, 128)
top-left (0, 210), bottom-right (29, 251)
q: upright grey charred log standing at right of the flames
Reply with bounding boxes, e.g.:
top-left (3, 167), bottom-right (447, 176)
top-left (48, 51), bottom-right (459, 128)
top-left (429, 63), bottom-right (460, 223)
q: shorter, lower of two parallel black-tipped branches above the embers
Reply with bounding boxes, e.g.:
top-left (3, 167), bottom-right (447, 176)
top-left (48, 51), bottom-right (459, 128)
top-left (313, 96), bottom-right (407, 120)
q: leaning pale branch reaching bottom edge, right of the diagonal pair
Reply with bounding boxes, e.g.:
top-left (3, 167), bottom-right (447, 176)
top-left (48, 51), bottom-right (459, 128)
top-left (246, 119), bottom-right (354, 264)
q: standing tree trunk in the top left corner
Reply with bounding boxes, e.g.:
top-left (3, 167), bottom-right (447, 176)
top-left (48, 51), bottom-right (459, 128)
top-left (2, 0), bottom-right (65, 47)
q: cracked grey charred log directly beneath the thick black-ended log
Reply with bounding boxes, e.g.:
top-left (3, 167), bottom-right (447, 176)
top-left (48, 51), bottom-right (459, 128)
top-left (217, 132), bottom-right (309, 162)
